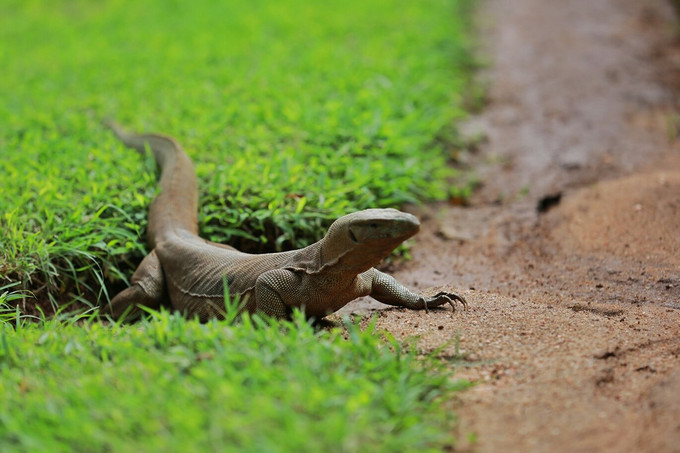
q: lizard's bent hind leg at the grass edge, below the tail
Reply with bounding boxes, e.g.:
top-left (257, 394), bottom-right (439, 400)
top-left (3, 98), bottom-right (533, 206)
top-left (101, 250), bottom-right (166, 321)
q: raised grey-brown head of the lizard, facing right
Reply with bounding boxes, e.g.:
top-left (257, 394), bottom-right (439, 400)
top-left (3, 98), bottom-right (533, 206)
top-left (322, 209), bottom-right (420, 272)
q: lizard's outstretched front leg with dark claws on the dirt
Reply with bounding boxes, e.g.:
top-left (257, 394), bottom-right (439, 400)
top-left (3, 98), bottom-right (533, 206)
top-left (364, 269), bottom-right (468, 311)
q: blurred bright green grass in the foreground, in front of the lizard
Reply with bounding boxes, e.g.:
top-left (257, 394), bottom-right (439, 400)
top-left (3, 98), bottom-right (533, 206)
top-left (0, 313), bottom-right (468, 452)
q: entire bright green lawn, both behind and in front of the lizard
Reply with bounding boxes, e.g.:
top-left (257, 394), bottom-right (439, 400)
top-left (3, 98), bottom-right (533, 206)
top-left (0, 0), bottom-right (477, 446)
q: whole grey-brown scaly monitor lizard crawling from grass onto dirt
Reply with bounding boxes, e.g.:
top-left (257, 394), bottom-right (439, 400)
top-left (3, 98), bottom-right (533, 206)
top-left (102, 123), bottom-right (467, 321)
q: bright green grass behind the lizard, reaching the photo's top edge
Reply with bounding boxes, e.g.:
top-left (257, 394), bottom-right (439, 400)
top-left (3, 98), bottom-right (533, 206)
top-left (0, 0), bottom-right (474, 310)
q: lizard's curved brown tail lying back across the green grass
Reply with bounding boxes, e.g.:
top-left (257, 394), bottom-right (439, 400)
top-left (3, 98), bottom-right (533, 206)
top-left (104, 120), bottom-right (198, 248)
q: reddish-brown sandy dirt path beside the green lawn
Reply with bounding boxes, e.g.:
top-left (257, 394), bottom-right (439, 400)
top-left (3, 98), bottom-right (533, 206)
top-left (336, 0), bottom-right (680, 452)
